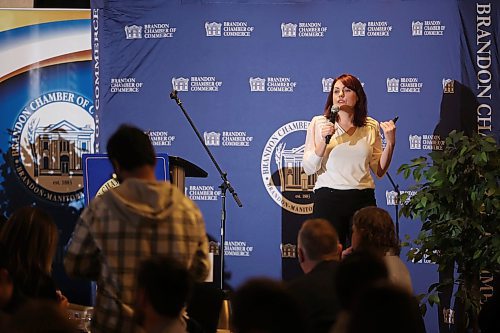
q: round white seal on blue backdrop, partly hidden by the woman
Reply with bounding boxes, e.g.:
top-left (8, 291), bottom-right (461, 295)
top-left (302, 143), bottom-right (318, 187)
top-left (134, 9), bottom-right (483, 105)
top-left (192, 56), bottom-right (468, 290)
top-left (260, 120), bottom-right (316, 215)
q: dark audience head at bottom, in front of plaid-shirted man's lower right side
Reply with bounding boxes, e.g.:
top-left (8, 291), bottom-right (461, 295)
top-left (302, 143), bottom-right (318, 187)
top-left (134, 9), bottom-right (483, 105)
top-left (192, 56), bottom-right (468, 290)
top-left (134, 257), bottom-right (194, 333)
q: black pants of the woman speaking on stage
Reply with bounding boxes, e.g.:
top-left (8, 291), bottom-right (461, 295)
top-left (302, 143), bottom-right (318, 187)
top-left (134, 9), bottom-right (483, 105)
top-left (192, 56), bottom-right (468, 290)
top-left (313, 187), bottom-right (377, 249)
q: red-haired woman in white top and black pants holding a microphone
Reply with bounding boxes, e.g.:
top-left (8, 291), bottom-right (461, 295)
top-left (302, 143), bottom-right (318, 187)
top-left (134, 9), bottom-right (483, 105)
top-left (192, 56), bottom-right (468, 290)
top-left (302, 74), bottom-right (396, 248)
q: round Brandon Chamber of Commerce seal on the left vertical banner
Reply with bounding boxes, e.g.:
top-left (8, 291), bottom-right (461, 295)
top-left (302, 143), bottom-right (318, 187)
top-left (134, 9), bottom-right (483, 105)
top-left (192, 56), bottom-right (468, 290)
top-left (11, 91), bottom-right (99, 202)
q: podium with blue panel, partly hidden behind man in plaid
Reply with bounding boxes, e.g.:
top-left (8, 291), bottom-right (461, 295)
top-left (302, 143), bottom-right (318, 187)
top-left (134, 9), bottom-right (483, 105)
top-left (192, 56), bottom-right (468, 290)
top-left (82, 154), bottom-right (208, 205)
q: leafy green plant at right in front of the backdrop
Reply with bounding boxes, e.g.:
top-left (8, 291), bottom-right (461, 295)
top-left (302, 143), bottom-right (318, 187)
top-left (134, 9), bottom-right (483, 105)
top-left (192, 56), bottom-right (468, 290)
top-left (398, 131), bottom-right (500, 332)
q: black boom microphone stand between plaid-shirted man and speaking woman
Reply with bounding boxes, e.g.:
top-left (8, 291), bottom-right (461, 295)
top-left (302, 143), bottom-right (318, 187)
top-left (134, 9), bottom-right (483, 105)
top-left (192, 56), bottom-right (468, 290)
top-left (170, 90), bottom-right (243, 291)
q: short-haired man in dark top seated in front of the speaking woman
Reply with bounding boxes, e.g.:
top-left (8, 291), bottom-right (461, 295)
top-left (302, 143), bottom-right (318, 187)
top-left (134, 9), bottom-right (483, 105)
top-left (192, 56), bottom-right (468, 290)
top-left (289, 219), bottom-right (342, 333)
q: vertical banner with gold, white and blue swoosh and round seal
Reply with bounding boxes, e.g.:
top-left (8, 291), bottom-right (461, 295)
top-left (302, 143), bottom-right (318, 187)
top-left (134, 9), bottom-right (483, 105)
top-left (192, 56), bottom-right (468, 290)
top-left (0, 9), bottom-right (98, 304)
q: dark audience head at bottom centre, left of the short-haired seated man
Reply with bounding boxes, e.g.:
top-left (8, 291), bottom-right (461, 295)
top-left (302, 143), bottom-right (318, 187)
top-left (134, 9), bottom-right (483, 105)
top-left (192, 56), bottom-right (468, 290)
top-left (231, 278), bottom-right (304, 333)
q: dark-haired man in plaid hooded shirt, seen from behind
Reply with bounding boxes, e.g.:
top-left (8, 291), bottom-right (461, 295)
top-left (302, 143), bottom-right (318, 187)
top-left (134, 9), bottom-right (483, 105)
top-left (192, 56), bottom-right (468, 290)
top-left (64, 125), bottom-right (210, 333)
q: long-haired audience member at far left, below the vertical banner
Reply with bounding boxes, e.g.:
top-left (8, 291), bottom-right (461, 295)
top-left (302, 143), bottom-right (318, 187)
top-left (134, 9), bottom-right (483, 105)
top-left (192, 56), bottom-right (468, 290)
top-left (0, 207), bottom-right (68, 305)
